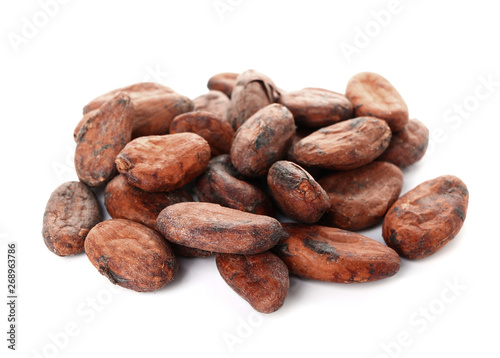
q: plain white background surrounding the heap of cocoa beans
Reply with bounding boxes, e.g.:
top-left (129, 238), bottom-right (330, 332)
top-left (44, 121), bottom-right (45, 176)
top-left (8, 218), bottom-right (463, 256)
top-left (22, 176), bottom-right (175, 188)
top-left (0, 0), bottom-right (500, 358)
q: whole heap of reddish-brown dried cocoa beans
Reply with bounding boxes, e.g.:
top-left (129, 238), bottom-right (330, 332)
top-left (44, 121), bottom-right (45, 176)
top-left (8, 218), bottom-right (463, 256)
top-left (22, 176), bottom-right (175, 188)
top-left (43, 70), bottom-right (468, 313)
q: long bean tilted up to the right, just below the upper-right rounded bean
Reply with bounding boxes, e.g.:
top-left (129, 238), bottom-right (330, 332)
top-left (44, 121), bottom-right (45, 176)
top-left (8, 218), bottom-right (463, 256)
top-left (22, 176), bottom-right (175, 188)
top-left (293, 117), bottom-right (391, 170)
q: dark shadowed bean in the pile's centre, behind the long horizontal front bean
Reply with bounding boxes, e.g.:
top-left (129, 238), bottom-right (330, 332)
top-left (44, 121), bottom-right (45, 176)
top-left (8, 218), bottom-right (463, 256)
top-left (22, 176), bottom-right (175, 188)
top-left (196, 154), bottom-right (274, 216)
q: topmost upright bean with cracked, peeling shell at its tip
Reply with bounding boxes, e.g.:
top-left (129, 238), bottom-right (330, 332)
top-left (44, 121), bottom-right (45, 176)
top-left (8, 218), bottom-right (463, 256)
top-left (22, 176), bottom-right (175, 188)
top-left (227, 70), bottom-right (279, 129)
